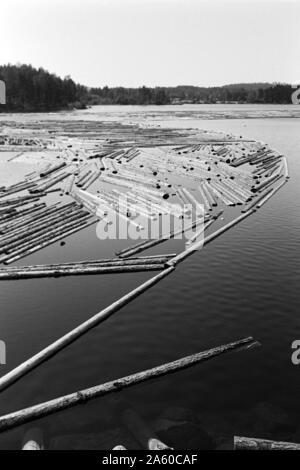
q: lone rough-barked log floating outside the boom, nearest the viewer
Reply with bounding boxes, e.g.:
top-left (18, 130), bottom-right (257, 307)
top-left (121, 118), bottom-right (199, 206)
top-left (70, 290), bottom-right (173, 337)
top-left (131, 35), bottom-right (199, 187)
top-left (0, 337), bottom-right (257, 432)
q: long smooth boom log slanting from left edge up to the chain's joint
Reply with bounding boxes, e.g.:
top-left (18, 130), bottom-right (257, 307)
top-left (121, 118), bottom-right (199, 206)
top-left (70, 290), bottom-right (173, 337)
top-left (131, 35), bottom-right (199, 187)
top-left (0, 266), bottom-right (175, 391)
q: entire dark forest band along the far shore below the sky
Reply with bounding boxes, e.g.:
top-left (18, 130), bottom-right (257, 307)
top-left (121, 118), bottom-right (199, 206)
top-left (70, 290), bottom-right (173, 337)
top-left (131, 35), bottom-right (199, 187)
top-left (0, 65), bottom-right (294, 112)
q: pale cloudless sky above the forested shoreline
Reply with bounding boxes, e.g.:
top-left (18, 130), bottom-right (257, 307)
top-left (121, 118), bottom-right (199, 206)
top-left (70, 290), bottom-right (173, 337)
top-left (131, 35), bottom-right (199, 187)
top-left (0, 0), bottom-right (300, 86)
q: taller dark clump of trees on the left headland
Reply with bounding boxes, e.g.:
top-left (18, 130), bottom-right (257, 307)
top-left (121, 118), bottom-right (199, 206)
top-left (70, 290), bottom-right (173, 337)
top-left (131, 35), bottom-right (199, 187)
top-left (0, 65), bottom-right (88, 112)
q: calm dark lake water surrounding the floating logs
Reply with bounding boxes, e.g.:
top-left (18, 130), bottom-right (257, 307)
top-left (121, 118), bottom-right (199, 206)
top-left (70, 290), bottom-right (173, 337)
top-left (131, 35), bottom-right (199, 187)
top-left (0, 107), bottom-right (300, 448)
